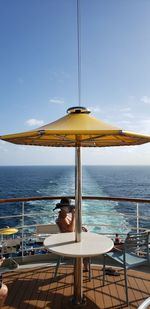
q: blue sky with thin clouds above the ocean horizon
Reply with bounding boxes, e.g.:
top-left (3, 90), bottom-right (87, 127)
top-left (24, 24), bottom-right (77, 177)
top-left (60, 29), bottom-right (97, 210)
top-left (0, 0), bottom-right (150, 165)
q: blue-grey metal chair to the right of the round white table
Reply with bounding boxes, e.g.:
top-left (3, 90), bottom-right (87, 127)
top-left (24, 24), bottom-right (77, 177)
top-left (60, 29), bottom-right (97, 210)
top-left (103, 232), bottom-right (150, 304)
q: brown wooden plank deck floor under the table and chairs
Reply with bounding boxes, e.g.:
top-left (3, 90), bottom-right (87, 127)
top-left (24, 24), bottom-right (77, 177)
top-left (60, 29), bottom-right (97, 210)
top-left (3, 265), bottom-right (150, 309)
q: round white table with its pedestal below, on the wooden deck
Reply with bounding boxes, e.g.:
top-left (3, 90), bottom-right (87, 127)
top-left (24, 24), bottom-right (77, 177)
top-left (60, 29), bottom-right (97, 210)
top-left (44, 232), bottom-right (114, 306)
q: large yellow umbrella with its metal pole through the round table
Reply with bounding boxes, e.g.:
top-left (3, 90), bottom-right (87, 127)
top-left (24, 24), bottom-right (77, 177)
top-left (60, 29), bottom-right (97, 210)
top-left (0, 107), bottom-right (150, 303)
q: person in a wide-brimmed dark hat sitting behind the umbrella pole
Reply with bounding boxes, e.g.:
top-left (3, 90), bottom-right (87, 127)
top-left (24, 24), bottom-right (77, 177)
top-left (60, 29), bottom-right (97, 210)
top-left (53, 197), bottom-right (89, 271)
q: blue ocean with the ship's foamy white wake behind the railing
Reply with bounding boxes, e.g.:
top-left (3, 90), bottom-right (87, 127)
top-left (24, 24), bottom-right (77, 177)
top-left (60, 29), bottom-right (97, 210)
top-left (0, 166), bottom-right (150, 233)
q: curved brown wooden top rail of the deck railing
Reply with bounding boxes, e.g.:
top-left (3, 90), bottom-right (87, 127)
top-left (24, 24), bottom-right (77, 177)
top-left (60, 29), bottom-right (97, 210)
top-left (0, 195), bottom-right (150, 204)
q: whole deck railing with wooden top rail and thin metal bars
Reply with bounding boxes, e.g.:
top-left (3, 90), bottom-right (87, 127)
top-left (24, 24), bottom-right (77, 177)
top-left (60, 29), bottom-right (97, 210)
top-left (0, 196), bottom-right (150, 256)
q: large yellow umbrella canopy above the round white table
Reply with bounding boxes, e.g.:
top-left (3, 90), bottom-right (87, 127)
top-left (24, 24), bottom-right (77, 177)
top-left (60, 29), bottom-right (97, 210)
top-left (0, 107), bottom-right (150, 147)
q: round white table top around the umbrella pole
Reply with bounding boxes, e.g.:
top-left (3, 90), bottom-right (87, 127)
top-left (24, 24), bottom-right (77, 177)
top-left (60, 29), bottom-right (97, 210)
top-left (44, 232), bottom-right (114, 257)
